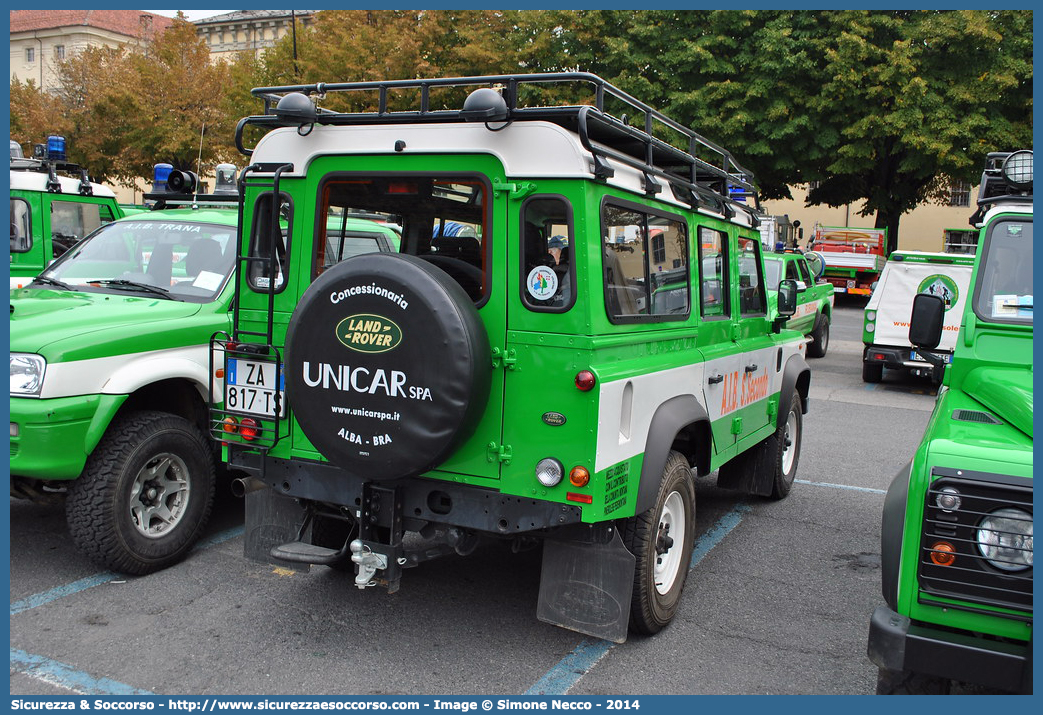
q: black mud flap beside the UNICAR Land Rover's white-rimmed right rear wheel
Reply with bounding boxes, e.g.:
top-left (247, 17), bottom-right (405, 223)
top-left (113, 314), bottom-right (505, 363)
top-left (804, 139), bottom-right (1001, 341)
top-left (536, 529), bottom-right (636, 643)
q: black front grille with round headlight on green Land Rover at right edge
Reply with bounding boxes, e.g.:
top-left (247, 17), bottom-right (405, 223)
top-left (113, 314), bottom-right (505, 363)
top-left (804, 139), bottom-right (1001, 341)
top-left (919, 469), bottom-right (1033, 613)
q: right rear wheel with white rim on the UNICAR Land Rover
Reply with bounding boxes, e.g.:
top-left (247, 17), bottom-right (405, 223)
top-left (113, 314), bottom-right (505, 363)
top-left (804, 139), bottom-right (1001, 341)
top-left (620, 451), bottom-right (696, 635)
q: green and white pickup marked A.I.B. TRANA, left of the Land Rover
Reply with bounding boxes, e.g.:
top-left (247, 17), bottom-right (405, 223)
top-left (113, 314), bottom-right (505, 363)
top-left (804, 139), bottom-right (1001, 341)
top-left (10, 191), bottom-right (238, 574)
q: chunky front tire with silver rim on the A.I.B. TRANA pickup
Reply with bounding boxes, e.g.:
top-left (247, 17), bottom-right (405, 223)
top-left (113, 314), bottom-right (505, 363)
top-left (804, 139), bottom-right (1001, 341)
top-left (66, 411), bottom-right (216, 575)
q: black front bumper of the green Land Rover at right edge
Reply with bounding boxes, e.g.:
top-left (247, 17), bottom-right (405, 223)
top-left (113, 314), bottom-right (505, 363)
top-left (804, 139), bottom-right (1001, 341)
top-left (869, 606), bottom-right (1032, 693)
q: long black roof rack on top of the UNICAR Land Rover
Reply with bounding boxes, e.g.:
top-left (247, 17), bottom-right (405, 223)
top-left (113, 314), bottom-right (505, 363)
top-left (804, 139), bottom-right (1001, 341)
top-left (236, 72), bottom-right (759, 223)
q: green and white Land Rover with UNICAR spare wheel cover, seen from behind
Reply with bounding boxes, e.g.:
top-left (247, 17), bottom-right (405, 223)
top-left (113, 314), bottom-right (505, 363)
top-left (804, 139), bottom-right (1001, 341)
top-left (211, 73), bottom-right (810, 642)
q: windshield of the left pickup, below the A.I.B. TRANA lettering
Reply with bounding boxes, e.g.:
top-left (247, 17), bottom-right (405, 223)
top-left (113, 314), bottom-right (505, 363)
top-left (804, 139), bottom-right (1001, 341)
top-left (37, 219), bottom-right (236, 302)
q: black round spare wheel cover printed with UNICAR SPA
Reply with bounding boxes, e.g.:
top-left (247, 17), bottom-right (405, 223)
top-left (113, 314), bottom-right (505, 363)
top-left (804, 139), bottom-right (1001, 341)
top-left (285, 253), bottom-right (491, 479)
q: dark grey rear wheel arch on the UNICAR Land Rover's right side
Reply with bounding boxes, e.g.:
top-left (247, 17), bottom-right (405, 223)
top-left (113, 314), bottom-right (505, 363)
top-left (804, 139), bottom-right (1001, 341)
top-left (634, 394), bottom-right (710, 514)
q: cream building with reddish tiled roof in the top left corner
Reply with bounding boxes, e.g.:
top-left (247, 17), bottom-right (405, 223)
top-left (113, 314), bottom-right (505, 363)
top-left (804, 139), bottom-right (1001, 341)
top-left (10, 10), bottom-right (172, 90)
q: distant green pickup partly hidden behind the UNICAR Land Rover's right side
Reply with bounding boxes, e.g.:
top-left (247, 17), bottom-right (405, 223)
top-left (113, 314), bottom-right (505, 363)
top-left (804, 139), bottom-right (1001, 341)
top-left (763, 250), bottom-right (833, 358)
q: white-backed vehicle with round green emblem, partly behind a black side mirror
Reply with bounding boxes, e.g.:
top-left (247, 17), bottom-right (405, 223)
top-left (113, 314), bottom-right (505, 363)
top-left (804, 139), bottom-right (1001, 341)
top-left (862, 251), bottom-right (974, 384)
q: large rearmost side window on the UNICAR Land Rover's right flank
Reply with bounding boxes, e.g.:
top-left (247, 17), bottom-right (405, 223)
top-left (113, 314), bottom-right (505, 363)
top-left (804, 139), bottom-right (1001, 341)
top-left (602, 204), bottom-right (692, 322)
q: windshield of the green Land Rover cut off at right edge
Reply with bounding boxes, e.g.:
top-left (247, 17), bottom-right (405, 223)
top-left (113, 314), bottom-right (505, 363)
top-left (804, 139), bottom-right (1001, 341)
top-left (974, 219), bottom-right (1033, 325)
